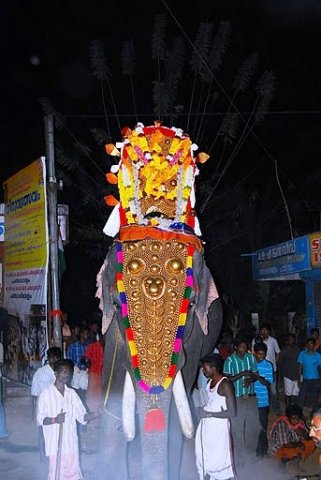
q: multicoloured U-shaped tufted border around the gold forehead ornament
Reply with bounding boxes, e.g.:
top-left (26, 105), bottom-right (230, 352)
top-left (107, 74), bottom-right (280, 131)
top-left (116, 242), bottom-right (195, 395)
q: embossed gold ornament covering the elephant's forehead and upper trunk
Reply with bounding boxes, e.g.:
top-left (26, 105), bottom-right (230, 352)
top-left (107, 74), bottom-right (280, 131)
top-left (123, 239), bottom-right (187, 385)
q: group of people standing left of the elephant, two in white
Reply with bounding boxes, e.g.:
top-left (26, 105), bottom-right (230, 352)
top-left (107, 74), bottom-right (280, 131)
top-left (31, 322), bottom-right (104, 480)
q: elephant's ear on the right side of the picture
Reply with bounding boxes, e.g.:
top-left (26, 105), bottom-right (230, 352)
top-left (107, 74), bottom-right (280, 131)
top-left (193, 253), bottom-right (219, 335)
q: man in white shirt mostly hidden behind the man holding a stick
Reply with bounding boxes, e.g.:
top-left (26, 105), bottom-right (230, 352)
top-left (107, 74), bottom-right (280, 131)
top-left (31, 347), bottom-right (62, 462)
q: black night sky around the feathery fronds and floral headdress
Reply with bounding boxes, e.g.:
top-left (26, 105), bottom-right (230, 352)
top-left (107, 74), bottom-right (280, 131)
top-left (0, 0), bottom-right (321, 322)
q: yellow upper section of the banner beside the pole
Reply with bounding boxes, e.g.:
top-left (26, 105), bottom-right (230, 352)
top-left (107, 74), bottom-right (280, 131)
top-left (4, 159), bottom-right (48, 272)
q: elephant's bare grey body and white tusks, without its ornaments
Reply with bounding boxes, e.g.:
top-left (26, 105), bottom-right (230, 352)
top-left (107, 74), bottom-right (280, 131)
top-left (97, 244), bottom-right (222, 480)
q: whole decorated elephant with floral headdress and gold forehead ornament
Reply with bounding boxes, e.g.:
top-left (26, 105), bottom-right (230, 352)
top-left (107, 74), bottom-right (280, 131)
top-left (97, 122), bottom-right (222, 480)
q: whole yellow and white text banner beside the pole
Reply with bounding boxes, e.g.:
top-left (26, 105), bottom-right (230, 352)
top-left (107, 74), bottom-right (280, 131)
top-left (3, 158), bottom-right (48, 324)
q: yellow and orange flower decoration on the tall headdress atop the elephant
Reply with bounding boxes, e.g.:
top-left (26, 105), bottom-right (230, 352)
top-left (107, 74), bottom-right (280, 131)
top-left (118, 124), bottom-right (196, 227)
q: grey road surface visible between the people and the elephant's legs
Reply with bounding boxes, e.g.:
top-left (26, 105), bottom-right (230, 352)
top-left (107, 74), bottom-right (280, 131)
top-left (0, 390), bottom-right (312, 480)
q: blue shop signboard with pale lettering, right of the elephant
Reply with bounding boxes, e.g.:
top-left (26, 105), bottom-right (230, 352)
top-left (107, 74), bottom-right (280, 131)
top-left (252, 236), bottom-right (311, 280)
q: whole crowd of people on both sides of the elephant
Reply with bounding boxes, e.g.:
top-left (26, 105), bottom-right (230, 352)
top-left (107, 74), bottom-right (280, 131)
top-left (24, 323), bottom-right (321, 480)
